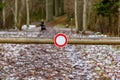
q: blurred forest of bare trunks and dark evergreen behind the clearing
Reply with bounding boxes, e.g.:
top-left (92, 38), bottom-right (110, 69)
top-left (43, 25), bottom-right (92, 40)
top-left (0, 0), bottom-right (120, 36)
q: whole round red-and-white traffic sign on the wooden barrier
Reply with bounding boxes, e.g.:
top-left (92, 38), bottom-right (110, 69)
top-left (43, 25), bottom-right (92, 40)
top-left (54, 33), bottom-right (68, 47)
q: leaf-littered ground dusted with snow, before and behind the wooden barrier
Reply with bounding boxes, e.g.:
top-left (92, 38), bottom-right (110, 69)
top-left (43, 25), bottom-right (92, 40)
top-left (0, 29), bottom-right (120, 80)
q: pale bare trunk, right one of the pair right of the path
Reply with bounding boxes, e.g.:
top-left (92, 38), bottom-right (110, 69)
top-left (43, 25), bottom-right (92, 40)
top-left (83, 0), bottom-right (87, 31)
